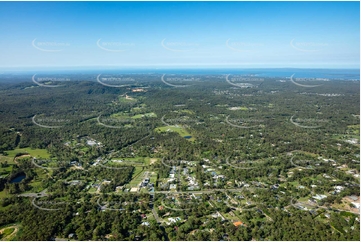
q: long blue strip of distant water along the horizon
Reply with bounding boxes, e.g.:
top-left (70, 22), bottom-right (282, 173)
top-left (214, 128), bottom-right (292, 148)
top-left (0, 68), bottom-right (360, 83)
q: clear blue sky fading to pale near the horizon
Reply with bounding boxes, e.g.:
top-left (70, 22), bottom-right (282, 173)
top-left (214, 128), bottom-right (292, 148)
top-left (0, 2), bottom-right (360, 70)
